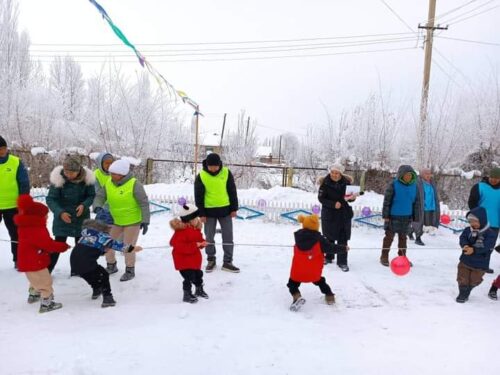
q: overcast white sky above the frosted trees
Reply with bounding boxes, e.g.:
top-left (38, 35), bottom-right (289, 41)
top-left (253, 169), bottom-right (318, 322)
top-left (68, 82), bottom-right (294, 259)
top-left (14, 0), bottom-right (500, 135)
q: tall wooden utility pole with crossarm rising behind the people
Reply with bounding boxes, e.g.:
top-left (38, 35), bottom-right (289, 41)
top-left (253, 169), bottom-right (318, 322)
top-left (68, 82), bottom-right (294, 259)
top-left (417, 0), bottom-right (448, 168)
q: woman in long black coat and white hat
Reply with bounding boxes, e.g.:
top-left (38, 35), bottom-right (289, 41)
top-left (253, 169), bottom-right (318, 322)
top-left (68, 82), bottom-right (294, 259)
top-left (318, 165), bottom-right (354, 272)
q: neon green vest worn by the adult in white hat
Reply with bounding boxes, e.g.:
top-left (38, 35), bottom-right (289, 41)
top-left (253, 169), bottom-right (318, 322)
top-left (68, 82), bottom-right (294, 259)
top-left (104, 178), bottom-right (142, 226)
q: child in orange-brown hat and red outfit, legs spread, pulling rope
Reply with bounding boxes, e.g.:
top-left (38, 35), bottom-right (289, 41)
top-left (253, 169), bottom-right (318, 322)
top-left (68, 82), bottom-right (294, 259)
top-left (287, 215), bottom-right (347, 311)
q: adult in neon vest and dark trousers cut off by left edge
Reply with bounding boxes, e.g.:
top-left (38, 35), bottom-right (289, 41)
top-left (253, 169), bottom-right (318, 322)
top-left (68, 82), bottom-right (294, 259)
top-left (0, 136), bottom-right (30, 269)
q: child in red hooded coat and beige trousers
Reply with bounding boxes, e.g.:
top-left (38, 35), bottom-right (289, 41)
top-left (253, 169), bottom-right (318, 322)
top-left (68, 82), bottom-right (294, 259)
top-left (14, 194), bottom-right (69, 313)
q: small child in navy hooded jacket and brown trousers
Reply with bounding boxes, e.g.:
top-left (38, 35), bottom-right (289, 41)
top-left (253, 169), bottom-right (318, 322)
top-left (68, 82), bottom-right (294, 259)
top-left (456, 207), bottom-right (496, 303)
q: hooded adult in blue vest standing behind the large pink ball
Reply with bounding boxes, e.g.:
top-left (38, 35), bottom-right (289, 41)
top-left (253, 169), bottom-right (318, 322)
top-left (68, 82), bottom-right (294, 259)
top-left (380, 165), bottom-right (420, 267)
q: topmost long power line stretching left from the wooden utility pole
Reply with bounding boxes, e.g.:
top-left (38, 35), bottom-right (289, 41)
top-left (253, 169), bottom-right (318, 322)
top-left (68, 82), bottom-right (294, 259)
top-left (31, 31), bottom-right (415, 47)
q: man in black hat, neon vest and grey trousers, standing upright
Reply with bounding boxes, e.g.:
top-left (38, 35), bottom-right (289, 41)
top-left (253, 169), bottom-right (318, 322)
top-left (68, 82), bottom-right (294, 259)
top-left (194, 153), bottom-right (240, 272)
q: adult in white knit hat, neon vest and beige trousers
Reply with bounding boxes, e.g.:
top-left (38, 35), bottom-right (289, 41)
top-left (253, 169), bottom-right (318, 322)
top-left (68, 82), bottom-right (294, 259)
top-left (94, 159), bottom-right (150, 281)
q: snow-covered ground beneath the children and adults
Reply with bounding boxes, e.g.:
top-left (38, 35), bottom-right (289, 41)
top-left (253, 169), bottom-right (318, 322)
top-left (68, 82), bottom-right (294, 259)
top-left (0, 187), bottom-right (500, 375)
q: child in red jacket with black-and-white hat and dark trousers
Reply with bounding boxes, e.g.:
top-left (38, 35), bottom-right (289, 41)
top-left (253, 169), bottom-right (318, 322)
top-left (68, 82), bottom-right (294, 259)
top-left (170, 204), bottom-right (208, 303)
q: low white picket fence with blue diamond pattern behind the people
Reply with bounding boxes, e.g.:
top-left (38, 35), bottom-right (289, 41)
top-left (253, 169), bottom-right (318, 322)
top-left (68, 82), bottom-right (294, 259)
top-left (31, 188), bottom-right (466, 227)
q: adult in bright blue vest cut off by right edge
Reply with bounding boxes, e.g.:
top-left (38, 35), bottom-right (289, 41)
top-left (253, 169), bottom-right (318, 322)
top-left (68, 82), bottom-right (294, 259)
top-left (468, 167), bottom-right (500, 273)
